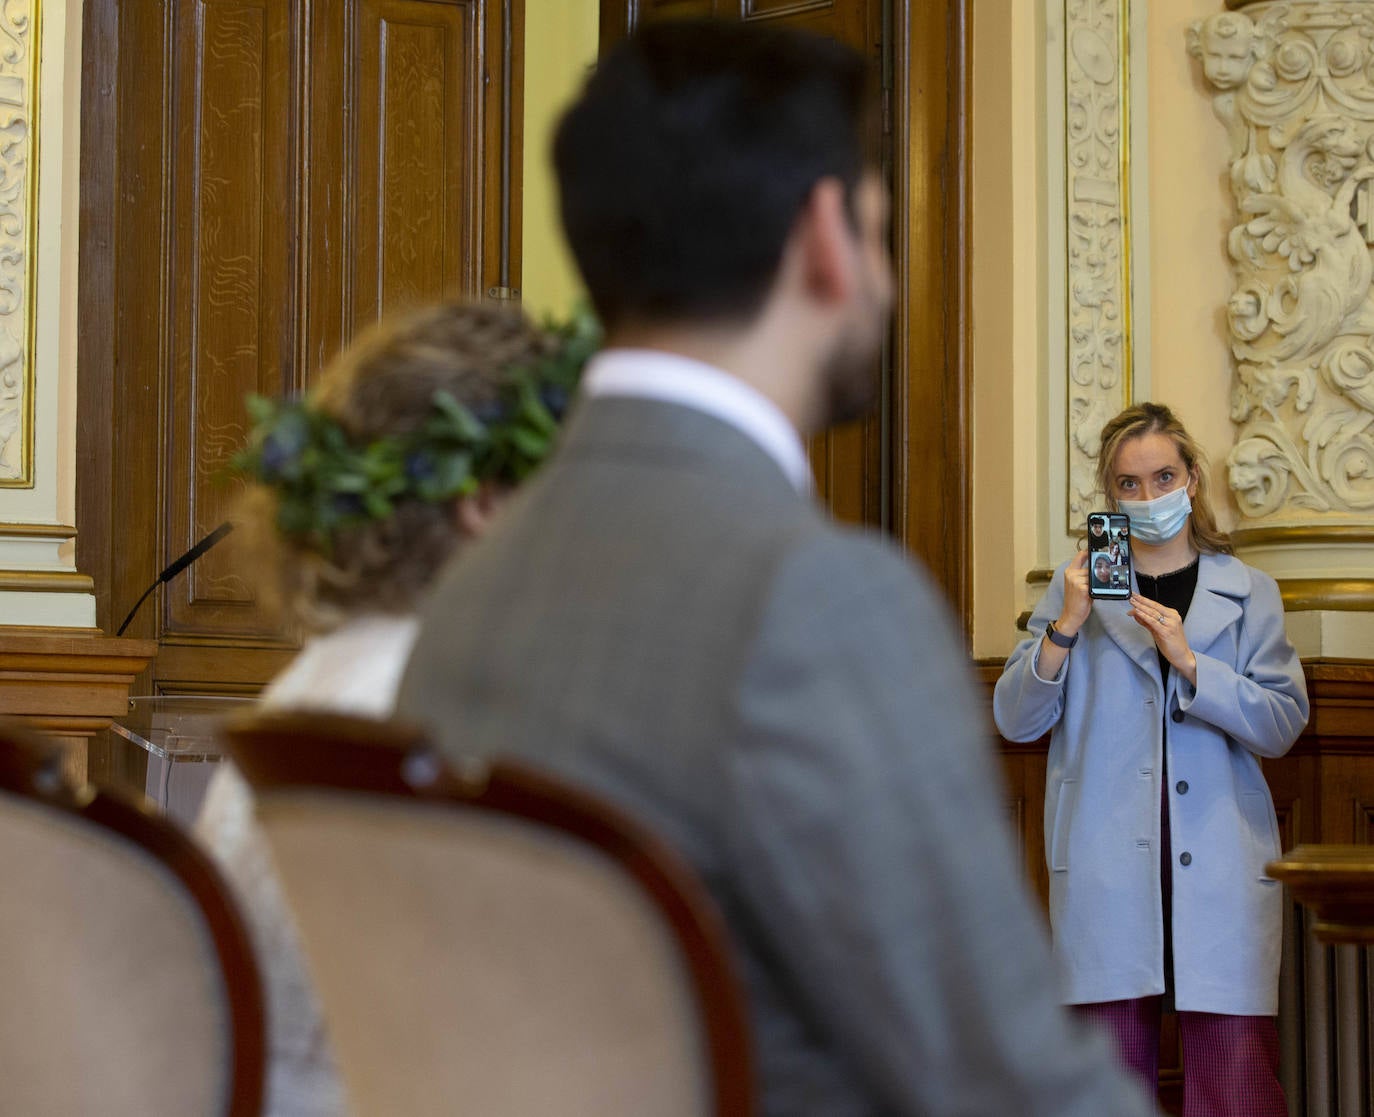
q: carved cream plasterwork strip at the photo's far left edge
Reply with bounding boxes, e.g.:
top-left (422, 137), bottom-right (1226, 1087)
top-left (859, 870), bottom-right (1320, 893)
top-left (0, 0), bottom-right (38, 486)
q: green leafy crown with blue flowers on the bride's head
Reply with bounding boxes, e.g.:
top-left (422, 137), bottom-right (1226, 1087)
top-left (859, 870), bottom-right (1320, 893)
top-left (229, 308), bottom-right (600, 554)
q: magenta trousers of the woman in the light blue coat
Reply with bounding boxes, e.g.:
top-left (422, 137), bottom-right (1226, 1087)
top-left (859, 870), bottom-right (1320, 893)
top-left (1074, 996), bottom-right (1287, 1117)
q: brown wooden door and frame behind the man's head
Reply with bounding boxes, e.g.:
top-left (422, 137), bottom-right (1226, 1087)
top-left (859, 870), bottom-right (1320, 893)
top-left (600, 0), bottom-right (973, 626)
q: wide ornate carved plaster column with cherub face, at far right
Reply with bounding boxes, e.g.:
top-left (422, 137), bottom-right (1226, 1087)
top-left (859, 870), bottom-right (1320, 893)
top-left (1189, 0), bottom-right (1374, 526)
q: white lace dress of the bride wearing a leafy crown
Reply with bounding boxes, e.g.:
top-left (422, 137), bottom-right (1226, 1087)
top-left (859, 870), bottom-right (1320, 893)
top-left (195, 616), bottom-right (419, 1117)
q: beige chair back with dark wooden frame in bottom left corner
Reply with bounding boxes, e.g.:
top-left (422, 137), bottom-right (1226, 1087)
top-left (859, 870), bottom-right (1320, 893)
top-left (0, 723), bottom-right (264, 1117)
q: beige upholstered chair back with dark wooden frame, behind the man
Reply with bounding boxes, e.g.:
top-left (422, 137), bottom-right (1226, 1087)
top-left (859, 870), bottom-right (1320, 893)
top-left (225, 714), bottom-right (753, 1117)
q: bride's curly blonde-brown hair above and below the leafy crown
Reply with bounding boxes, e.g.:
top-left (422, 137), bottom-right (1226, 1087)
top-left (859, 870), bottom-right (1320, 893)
top-left (245, 302), bottom-right (558, 632)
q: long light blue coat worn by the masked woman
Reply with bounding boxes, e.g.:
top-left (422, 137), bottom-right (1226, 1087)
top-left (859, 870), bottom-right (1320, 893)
top-left (993, 555), bottom-right (1308, 1015)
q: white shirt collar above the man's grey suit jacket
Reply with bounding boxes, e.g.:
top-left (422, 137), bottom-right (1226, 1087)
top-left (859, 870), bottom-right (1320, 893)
top-left (581, 349), bottom-right (812, 493)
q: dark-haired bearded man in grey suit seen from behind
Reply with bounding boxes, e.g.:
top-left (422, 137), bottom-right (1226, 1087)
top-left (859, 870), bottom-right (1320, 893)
top-left (400, 25), bottom-right (1153, 1117)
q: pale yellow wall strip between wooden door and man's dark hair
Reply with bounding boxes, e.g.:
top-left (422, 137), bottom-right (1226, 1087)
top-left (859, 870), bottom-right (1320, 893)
top-left (521, 0), bottom-right (598, 319)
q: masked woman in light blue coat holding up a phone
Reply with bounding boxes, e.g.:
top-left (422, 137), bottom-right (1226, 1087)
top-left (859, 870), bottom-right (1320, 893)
top-left (993, 404), bottom-right (1308, 1117)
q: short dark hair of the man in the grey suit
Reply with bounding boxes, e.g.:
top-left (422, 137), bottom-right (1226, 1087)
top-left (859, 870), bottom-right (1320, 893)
top-left (554, 21), bottom-right (877, 328)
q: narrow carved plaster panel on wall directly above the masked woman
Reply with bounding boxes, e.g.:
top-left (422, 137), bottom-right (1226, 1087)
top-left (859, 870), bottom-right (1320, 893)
top-left (1065, 0), bottom-right (1131, 532)
